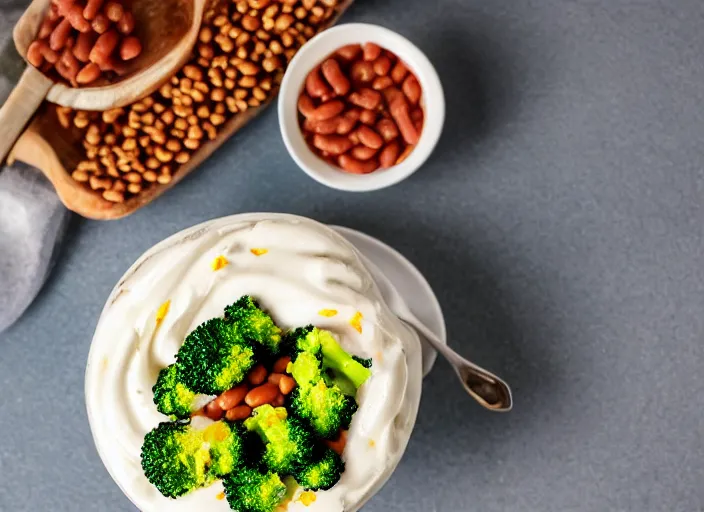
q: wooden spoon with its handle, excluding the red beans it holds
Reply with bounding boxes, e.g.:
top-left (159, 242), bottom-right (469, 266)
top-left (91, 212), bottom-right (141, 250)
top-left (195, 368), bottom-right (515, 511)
top-left (0, 0), bottom-right (207, 163)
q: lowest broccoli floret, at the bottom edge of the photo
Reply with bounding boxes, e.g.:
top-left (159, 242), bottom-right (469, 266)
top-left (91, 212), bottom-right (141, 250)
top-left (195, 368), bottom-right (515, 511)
top-left (223, 467), bottom-right (286, 512)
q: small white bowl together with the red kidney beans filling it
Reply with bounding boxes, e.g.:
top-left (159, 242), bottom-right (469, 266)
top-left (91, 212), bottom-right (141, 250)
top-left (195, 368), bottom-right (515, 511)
top-left (278, 24), bottom-right (445, 192)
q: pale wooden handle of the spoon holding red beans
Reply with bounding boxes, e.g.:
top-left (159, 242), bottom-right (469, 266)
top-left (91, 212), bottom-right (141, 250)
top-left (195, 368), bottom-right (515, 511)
top-left (0, 66), bottom-right (54, 163)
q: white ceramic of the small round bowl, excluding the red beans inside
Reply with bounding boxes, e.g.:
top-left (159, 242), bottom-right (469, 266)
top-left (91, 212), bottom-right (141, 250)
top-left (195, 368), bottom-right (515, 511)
top-left (278, 23), bottom-right (445, 192)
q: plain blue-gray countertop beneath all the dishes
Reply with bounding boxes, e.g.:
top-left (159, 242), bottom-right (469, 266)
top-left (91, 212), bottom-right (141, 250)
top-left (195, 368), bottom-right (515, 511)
top-left (0, 0), bottom-right (704, 512)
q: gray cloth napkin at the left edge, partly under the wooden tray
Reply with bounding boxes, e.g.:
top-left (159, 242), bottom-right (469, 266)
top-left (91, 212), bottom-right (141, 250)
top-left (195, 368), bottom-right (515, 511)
top-left (0, 0), bottom-right (69, 333)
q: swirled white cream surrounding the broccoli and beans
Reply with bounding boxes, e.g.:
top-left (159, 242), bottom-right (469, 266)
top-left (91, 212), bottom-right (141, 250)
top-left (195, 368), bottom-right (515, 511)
top-left (86, 214), bottom-right (422, 512)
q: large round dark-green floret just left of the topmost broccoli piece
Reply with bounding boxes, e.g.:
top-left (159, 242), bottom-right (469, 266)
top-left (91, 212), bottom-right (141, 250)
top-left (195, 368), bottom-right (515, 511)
top-left (176, 318), bottom-right (255, 395)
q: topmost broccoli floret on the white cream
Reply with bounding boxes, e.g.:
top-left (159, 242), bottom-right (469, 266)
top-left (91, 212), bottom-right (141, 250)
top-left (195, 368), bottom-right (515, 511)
top-left (225, 295), bottom-right (281, 355)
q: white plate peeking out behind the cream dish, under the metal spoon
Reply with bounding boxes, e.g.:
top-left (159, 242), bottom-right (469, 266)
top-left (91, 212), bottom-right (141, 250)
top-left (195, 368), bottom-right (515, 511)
top-left (330, 226), bottom-right (447, 376)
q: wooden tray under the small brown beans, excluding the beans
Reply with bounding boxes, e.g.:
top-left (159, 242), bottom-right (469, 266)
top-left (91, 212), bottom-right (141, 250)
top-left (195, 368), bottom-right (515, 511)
top-left (9, 0), bottom-right (353, 220)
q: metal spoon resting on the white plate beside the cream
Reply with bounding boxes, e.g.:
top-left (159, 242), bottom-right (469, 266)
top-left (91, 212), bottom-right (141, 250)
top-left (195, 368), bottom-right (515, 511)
top-left (359, 254), bottom-right (513, 412)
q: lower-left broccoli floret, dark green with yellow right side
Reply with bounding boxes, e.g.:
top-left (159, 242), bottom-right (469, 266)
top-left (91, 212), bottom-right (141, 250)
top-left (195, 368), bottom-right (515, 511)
top-left (142, 423), bottom-right (212, 498)
